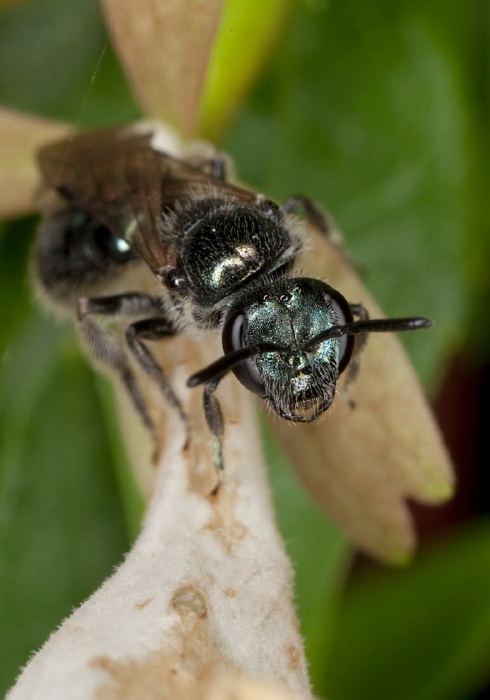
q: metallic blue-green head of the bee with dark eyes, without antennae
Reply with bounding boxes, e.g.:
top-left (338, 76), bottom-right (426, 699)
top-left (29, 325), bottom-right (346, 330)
top-left (223, 278), bottom-right (353, 422)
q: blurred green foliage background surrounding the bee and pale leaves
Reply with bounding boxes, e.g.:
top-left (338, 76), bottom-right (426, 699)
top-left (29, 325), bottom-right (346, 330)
top-left (0, 0), bottom-right (490, 700)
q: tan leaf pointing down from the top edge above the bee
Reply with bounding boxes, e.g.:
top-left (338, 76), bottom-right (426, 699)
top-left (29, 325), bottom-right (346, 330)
top-left (102, 0), bottom-right (223, 136)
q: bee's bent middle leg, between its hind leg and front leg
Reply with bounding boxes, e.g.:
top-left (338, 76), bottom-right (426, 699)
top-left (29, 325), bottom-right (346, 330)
top-left (126, 318), bottom-right (190, 448)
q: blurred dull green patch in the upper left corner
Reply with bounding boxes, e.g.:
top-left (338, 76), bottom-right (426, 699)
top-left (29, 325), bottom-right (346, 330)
top-left (0, 0), bottom-right (139, 127)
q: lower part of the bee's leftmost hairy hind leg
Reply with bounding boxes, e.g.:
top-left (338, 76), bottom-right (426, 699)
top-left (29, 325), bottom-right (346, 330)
top-left (78, 299), bottom-right (157, 445)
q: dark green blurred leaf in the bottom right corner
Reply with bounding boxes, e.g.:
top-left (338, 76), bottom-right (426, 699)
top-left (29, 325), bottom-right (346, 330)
top-left (321, 522), bottom-right (490, 700)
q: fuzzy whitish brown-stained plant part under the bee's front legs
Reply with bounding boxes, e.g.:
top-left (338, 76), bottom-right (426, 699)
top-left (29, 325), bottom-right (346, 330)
top-left (9, 272), bottom-right (310, 700)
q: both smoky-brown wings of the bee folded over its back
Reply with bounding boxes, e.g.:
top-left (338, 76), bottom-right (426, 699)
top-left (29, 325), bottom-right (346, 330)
top-left (39, 129), bottom-right (255, 272)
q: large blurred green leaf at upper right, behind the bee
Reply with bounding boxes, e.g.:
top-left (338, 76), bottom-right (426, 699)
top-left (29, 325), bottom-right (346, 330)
top-left (225, 0), bottom-right (474, 380)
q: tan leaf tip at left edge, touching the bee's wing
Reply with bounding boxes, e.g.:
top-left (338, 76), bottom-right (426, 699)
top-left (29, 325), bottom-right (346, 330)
top-left (0, 108), bottom-right (70, 218)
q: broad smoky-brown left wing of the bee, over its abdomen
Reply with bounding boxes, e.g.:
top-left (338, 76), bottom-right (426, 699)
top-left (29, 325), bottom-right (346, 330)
top-left (39, 130), bottom-right (174, 270)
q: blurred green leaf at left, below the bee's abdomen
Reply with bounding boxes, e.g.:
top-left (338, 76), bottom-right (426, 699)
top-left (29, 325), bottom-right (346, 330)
top-left (0, 314), bottom-right (129, 693)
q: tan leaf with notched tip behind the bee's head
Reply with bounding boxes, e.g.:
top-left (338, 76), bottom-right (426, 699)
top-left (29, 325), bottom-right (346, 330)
top-left (273, 231), bottom-right (453, 563)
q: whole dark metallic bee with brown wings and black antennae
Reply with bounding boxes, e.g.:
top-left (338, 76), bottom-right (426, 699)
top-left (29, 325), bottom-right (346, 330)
top-left (33, 129), bottom-right (431, 468)
